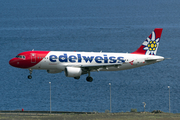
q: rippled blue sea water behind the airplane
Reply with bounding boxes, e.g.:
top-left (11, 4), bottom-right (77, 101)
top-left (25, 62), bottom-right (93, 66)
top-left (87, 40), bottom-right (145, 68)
top-left (0, 0), bottom-right (180, 113)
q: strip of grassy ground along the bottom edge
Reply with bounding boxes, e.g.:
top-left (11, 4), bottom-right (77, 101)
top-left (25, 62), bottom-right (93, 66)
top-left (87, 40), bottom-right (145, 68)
top-left (0, 112), bottom-right (180, 120)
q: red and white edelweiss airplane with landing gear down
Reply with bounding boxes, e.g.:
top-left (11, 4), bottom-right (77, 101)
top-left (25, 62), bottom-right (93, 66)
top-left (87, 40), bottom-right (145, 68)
top-left (9, 28), bottom-right (165, 82)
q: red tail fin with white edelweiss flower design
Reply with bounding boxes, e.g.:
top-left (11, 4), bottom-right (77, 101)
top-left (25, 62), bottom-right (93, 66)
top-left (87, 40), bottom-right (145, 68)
top-left (131, 28), bottom-right (163, 55)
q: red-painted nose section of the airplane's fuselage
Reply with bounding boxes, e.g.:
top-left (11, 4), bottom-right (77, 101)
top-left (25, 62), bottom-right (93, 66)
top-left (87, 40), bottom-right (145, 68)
top-left (9, 51), bottom-right (50, 68)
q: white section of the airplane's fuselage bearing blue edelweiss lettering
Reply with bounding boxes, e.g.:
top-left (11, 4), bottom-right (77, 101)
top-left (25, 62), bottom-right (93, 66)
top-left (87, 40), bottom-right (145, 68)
top-left (31, 51), bottom-right (164, 72)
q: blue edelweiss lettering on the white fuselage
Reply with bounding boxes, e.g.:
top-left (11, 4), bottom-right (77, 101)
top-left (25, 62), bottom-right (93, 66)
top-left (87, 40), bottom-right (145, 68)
top-left (49, 53), bottom-right (125, 63)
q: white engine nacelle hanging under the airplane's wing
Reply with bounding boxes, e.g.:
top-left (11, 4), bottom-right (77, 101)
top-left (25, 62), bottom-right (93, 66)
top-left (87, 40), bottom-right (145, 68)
top-left (64, 67), bottom-right (82, 77)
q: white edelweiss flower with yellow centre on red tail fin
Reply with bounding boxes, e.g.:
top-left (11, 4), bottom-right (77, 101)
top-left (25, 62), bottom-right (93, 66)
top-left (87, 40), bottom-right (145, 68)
top-left (142, 31), bottom-right (160, 55)
